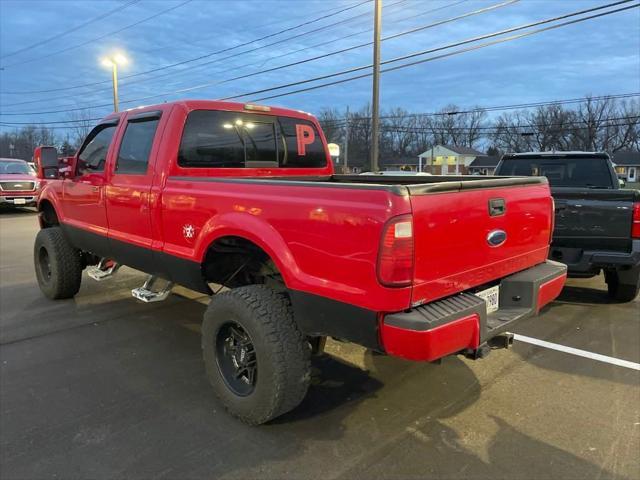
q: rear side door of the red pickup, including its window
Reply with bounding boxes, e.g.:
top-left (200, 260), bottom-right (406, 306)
top-left (106, 110), bottom-right (164, 272)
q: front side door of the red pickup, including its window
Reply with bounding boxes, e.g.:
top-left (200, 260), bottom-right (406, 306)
top-left (62, 119), bottom-right (118, 256)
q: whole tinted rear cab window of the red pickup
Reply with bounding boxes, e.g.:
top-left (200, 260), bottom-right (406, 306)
top-left (178, 110), bottom-right (327, 168)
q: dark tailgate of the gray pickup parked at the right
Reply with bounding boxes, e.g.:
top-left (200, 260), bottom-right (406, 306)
top-left (552, 187), bottom-right (637, 251)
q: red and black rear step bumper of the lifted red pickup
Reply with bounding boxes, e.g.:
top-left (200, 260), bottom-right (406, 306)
top-left (380, 260), bottom-right (567, 361)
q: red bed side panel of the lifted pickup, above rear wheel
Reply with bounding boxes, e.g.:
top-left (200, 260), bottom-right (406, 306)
top-left (162, 177), bottom-right (411, 311)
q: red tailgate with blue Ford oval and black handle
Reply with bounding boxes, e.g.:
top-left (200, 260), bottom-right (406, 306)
top-left (410, 181), bottom-right (552, 305)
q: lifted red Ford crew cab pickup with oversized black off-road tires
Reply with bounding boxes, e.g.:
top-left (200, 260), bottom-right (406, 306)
top-left (34, 101), bottom-right (566, 424)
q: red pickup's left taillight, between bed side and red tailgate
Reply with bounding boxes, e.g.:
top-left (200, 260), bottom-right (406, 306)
top-left (378, 215), bottom-right (413, 287)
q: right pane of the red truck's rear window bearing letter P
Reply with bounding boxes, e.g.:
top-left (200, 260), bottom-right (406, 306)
top-left (278, 117), bottom-right (327, 168)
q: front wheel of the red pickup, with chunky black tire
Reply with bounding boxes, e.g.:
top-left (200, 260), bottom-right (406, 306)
top-left (33, 227), bottom-right (82, 300)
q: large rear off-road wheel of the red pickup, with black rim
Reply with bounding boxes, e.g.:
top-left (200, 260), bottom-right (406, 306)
top-left (202, 285), bottom-right (311, 425)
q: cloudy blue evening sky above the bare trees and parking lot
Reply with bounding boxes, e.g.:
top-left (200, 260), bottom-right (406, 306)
top-left (0, 0), bottom-right (640, 133)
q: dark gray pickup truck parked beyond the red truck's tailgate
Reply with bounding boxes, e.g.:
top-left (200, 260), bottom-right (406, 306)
top-left (495, 152), bottom-right (640, 301)
